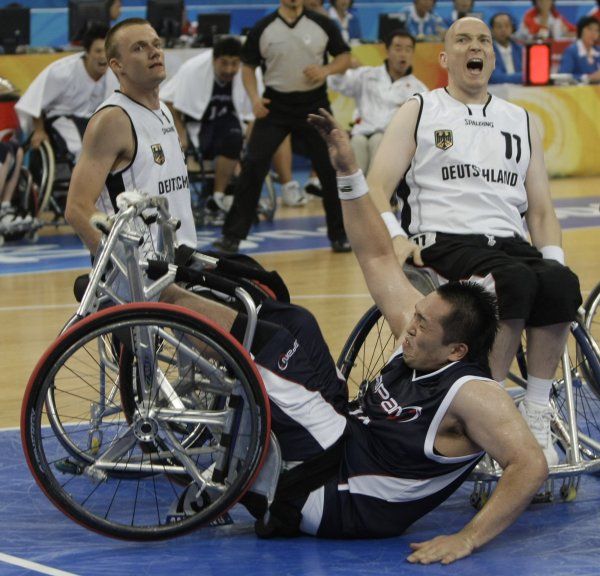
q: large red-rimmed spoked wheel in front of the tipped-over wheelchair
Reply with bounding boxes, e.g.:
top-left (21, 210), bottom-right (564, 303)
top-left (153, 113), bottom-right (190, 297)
top-left (21, 304), bottom-right (270, 540)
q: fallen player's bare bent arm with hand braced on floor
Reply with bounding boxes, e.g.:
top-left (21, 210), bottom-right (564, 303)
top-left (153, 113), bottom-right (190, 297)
top-left (408, 381), bottom-right (548, 564)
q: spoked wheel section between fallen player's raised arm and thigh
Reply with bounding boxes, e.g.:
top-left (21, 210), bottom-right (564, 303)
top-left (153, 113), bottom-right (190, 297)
top-left (337, 306), bottom-right (398, 390)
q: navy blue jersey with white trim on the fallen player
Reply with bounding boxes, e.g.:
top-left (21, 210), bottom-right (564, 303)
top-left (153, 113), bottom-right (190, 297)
top-left (317, 355), bottom-right (488, 538)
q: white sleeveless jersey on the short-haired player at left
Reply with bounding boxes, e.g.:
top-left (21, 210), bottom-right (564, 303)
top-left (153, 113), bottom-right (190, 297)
top-left (97, 92), bottom-right (197, 248)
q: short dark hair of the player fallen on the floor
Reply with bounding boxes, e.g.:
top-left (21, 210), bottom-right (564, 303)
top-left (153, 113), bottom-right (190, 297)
top-left (437, 282), bottom-right (499, 373)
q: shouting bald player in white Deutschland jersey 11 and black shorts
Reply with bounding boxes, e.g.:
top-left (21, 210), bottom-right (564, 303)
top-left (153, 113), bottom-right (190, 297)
top-left (369, 18), bottom-right (581, 464)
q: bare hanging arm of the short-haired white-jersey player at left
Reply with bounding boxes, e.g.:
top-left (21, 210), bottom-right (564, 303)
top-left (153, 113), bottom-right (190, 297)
top-left (65, 108), bottom-right (134, 254)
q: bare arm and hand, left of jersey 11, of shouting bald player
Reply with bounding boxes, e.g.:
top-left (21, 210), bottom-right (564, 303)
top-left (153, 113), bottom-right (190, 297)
top-left (367, 100), bottom-right (423, 265)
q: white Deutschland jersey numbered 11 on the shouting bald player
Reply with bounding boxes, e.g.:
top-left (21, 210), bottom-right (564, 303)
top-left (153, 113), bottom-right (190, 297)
top-left (398, 88), bottom-right (531, 237)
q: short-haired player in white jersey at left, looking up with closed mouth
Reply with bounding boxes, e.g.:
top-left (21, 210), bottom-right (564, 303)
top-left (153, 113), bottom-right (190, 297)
top-left (65, 18), bottom-right (228, 314)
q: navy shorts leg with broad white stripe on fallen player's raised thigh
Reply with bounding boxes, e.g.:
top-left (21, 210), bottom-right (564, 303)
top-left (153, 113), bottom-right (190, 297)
top-left (232, 300), bottom-right (348, 461)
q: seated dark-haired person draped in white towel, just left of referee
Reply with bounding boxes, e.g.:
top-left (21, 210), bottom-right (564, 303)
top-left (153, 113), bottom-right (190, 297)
top-left (160, 36), bottom-right (253, 211)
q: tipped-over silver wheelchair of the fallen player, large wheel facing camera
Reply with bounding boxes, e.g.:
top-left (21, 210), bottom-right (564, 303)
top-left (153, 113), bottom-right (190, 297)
top-left (21, 195), bottom-right (289, 540)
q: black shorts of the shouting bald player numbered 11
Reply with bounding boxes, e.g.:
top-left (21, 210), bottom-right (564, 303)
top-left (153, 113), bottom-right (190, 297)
top-left (421, 232), bottom-right (581, 327)
